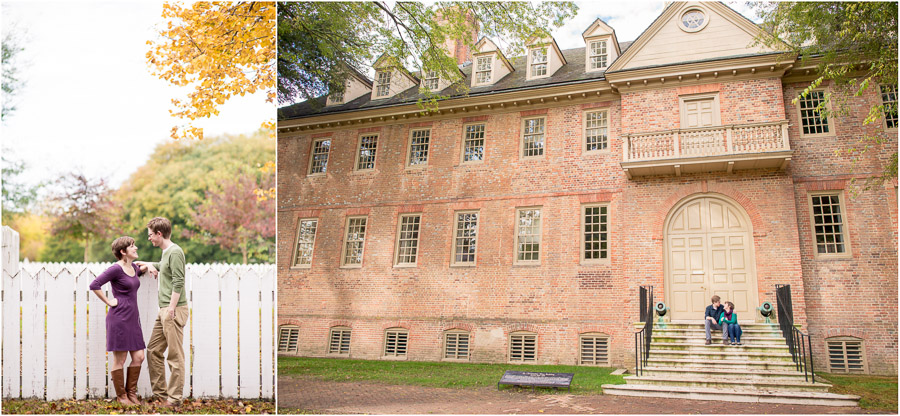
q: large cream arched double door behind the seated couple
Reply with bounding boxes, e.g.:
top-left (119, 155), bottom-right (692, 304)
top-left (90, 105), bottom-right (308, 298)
top-left (663, 194), bottom-right (758, 321)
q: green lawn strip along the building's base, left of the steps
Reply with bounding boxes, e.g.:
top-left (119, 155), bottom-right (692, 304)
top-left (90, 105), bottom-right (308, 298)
top-left (278, 357), bottom-right (625, 394)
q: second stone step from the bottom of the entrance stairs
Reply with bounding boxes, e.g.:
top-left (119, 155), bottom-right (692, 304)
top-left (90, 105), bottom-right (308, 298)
top-left (625, 374), bottom-right (831, 392)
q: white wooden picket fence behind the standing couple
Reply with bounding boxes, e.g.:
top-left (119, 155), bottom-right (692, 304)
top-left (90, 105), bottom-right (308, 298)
top-left (2, 227), bottom-right (275, 400)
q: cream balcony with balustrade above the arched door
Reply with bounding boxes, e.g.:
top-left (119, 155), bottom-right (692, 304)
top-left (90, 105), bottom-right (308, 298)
top-left (622, 120), bottom-right (793, 179)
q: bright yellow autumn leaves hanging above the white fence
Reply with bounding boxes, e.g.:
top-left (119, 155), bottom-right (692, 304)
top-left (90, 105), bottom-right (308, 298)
top-left (147, 2), bottom-right (277, 139)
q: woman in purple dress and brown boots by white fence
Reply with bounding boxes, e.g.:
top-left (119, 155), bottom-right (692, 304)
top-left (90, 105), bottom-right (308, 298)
top-left (90, 237), bottom-right (146, 405)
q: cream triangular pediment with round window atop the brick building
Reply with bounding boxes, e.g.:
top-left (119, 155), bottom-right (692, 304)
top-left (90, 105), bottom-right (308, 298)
top-left (609, 1), bottom-right (778, 72)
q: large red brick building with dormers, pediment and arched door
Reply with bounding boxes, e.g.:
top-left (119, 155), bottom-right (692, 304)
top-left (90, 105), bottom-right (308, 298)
top-left (277, 2), bottom-right (898, 374)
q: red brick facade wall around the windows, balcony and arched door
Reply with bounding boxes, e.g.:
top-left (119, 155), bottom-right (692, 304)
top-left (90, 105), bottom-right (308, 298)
top-left (278, 78), bottom-right (897, 371)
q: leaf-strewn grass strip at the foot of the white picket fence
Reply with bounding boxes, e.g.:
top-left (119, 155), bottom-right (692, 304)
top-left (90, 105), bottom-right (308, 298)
top-left (3, 399), bottom-right (275, 415)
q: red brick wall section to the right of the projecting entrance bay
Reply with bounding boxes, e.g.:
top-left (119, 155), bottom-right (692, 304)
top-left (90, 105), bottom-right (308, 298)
top-left (784, 83), bottom-right (898, 374)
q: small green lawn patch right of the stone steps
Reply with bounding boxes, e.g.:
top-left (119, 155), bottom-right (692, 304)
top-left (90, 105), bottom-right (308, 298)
top-left (816, 373), bottom-right (897, 414)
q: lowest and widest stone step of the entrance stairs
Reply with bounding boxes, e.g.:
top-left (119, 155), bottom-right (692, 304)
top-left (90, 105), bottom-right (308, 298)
top-left (601, 384), bottom-right (859, 407)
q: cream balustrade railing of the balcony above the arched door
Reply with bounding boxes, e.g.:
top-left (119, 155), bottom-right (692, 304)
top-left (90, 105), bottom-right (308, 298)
top-left (622, 120), bottom-right (790, 162)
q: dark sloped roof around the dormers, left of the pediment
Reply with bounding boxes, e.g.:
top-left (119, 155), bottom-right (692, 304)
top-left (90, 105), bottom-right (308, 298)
top-left (278, 42), bottom-right (631, 120)
